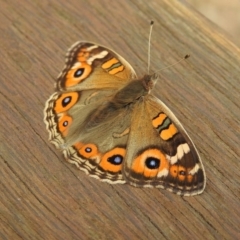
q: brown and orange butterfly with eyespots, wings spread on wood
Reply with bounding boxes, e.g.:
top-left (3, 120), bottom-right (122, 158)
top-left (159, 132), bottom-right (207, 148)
top-left (44, 37), bottom-right (206, 196)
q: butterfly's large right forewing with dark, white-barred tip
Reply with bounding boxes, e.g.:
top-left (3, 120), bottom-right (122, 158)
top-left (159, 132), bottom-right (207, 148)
top-left (124, 95), bottom-right (205, 195)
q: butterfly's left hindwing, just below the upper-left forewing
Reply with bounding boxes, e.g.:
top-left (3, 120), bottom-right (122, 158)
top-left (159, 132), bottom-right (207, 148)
top-left (44, 90), bottom-right (114, 148)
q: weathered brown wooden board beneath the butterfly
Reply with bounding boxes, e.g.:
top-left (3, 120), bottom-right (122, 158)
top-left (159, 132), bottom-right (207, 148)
top-left (0, 0), bottom-right (240, 240)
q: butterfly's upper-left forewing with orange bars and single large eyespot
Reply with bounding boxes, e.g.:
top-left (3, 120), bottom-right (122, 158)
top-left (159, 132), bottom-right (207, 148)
top-left (56, 42), bottom-right (136, 90)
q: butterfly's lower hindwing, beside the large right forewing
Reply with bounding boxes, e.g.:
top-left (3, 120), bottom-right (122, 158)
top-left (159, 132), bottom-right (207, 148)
top-left (63, 100), bottom-right (131, 183)
